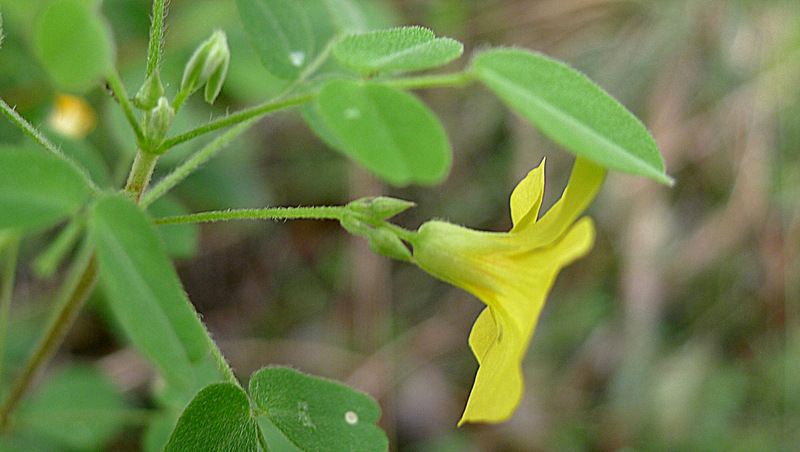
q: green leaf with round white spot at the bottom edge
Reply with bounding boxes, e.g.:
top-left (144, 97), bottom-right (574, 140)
top-left (250, 367), bottom-right (389, 452)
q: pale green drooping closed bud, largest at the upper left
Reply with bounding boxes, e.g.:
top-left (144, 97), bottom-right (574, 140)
top-left (180, 30), bottom-right (231, 99)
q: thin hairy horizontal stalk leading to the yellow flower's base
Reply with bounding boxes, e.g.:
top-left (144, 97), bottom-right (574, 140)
top-left (153, 206), bottom-right (348, 225)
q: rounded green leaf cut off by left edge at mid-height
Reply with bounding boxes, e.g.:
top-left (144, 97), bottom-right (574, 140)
top-left (0, 148), bottom-right (89, 231)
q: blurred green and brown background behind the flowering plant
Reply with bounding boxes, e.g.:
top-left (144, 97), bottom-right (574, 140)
top-left (0, 0), bottom-right (800, 451)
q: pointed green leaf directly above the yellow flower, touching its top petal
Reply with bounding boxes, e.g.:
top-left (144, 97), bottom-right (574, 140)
top-left (473, 49), bottom-right (672, 184)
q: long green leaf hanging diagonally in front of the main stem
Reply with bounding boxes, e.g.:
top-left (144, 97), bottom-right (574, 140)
top-left (90, 194), bottom-right (208, 384)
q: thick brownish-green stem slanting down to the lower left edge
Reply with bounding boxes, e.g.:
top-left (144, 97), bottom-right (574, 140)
top-left (0, 241), bottom-right (97, 427)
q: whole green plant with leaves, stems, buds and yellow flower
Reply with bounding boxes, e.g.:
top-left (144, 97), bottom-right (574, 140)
top-left (0, 0), bottom-right (671, 451)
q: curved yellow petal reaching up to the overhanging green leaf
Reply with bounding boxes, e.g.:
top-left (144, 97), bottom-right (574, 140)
top-left (520, 157), bottom-right (606, 246)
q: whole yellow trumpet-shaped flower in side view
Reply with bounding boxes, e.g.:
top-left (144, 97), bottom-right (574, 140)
top-left (413, 158), bottom-right (606, 425)
